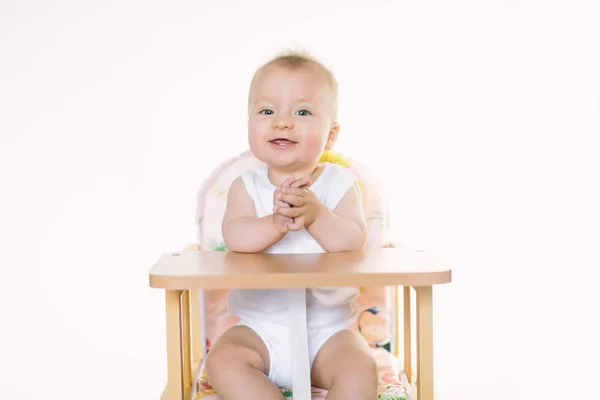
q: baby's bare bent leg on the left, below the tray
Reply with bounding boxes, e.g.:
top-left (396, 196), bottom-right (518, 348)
top-left (206, 326), bottom-right (283, 400)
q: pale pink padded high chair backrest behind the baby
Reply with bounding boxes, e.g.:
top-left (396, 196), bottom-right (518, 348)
top-left (196, 151), bottom-right (397, 351)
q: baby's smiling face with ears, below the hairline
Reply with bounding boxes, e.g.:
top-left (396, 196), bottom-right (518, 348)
top-left (248, 65), bottom-right (339, 172)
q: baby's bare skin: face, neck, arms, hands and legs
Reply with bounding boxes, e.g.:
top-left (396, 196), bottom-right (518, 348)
top-left (206, 54), bottom-right (377, 400)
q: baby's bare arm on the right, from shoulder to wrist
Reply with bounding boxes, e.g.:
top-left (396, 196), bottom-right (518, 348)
top-left (306, 185), bottom-right (367, 252)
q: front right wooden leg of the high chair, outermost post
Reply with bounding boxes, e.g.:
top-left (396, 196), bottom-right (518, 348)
top-left (415, 286), bottom-right (433, 400)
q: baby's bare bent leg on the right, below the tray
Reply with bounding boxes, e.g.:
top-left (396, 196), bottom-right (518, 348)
top-left (311, 329), bottom-right (378, 400)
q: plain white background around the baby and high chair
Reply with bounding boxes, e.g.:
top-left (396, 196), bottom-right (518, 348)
top-left (0, 0), bottom-right (600, 400)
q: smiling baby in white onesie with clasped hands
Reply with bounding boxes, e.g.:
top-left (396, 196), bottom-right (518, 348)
top-left (206, 53), bottom-right (377, 400)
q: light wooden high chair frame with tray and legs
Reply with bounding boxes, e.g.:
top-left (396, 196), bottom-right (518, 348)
top-left (150, 153), bottom-right (451, 400)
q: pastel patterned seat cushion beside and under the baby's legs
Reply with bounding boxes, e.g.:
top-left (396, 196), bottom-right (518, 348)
top-left (191, 348), bottom-right (411, 400)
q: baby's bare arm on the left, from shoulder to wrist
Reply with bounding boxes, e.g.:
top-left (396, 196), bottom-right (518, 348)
top-left (222, 178), bottom-right (285, 253)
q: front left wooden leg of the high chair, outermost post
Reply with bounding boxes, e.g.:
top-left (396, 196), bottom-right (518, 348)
top-left (163, 290), bottom-right (184, 400)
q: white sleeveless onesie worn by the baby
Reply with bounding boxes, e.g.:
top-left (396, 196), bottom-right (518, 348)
top-left (229, 163), bottom-right (359, 400)
